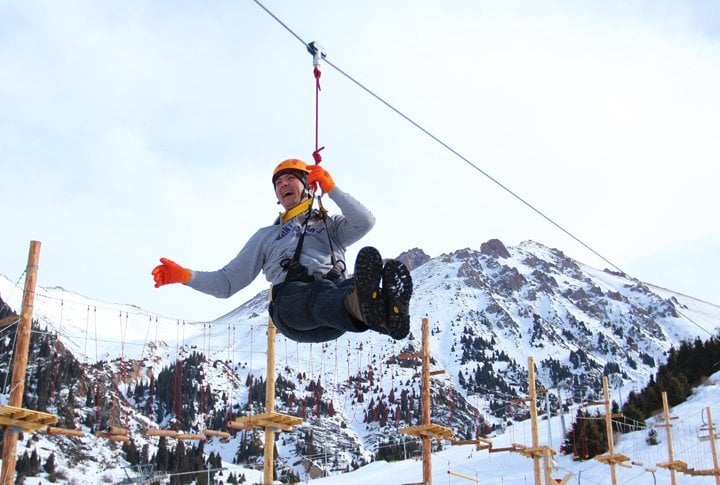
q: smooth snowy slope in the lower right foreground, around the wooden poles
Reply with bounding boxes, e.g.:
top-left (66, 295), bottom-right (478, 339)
top-left (312, 373), bottom-right (720, 485)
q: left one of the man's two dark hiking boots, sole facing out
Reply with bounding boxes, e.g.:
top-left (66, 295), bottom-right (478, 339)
top-left (345, 246), bottom-right (387, 333)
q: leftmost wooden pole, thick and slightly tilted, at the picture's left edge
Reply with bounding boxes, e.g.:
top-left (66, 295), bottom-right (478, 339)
top-left (0, 241), bottom-right (40, 485)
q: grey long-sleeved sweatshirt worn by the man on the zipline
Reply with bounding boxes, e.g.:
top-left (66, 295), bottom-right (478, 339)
top-left (187, 187), bottom-right (375, 298)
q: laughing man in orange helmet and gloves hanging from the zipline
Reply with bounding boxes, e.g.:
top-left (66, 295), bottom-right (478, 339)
top-left (152, 159), bottom-right (412, 342)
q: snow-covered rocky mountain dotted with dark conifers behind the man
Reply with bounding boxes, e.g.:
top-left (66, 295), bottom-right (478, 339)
top-left (0, 240), bottom-right (720, 483)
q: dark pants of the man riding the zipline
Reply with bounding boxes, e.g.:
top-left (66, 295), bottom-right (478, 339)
top-left (269, 278), bottom-right (368, 342)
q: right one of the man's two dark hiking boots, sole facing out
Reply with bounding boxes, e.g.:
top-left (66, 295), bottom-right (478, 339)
top-left (382, 259), bottom-right (412, 340)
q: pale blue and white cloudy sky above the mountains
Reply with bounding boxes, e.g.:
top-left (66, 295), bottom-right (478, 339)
top-left (0, 0), bottom-right (720, 320)
